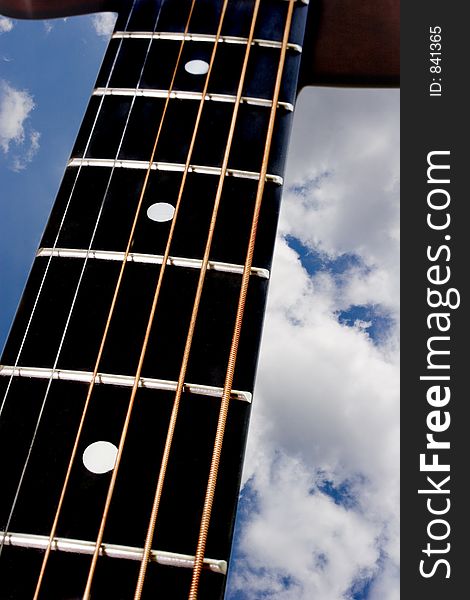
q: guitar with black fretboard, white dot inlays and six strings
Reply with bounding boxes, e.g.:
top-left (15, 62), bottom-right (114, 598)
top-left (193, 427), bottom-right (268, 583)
top-left (2, 2), bottom-right (394, 598)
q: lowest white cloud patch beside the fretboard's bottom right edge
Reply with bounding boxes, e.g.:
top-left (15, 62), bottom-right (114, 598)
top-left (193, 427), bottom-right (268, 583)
top-left (231, 455), bottom-right (379, 600)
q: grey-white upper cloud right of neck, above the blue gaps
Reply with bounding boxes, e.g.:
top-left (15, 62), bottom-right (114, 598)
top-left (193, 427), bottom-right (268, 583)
top-left (281, 89), bottom-right (399, 317)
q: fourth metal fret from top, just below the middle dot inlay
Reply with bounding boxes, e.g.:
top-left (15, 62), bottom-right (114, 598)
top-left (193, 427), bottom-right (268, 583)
top-left (36, 248), bottom-right (269, 279)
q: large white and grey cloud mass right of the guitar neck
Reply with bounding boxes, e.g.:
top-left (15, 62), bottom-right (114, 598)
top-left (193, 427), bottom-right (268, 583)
top-left (226, 90), bottom-right (399, 600)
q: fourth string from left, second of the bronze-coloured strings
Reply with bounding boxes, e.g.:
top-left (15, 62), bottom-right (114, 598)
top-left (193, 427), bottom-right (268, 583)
top-left (83, 0), bottom-right (233, 600)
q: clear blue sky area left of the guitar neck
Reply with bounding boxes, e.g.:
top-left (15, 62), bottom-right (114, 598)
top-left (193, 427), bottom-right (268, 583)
top-left (0, 17), bottom-right (106, 342)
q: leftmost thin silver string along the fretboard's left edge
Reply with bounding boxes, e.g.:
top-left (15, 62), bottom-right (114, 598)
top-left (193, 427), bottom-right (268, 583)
top-left (0, 0), bottom-right (138, 424)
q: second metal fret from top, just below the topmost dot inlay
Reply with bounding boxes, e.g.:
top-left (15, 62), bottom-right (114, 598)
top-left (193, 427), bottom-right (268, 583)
top-left (93, 88), bottom-right (294, 112)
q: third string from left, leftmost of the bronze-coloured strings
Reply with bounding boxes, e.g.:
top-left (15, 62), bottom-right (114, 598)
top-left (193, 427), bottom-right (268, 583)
top-left (30, 0), bottom-right (201, 599)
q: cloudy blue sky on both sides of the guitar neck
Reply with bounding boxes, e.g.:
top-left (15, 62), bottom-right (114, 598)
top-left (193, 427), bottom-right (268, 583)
top-left (0, 9), bottom-right (399, 600)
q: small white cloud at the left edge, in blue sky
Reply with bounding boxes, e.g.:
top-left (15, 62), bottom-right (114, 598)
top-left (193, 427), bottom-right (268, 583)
top-left (0, 81), bottom-right (40, 171)
